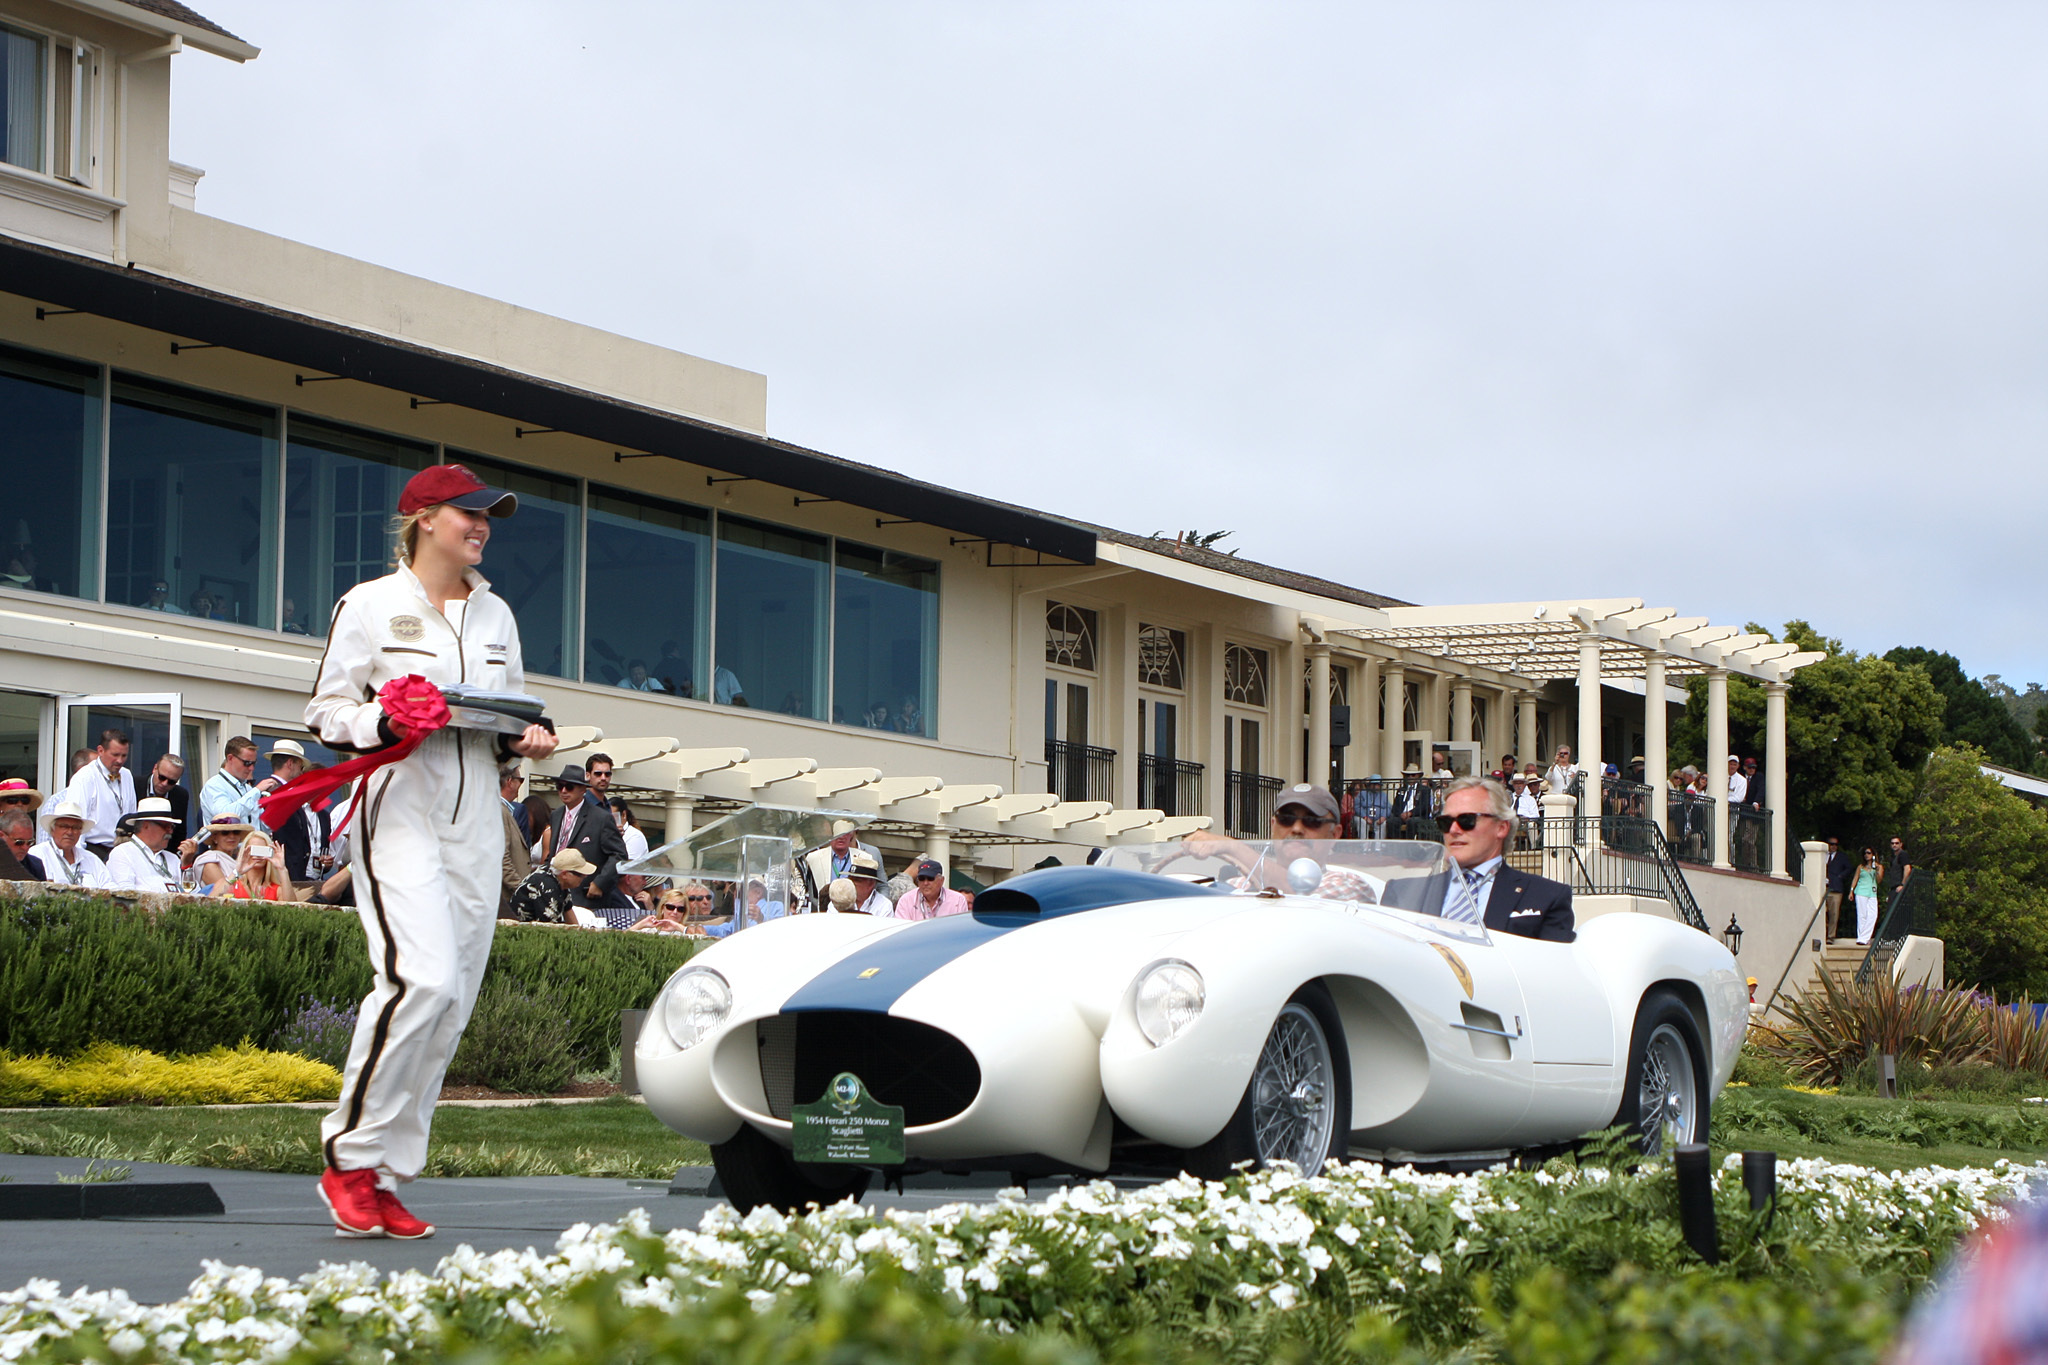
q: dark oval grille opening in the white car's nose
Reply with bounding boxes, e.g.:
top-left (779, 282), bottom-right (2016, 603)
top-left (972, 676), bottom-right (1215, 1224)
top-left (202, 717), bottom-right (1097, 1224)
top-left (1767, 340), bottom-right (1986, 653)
top-left (754, 1009), bottom-right (981, 1128)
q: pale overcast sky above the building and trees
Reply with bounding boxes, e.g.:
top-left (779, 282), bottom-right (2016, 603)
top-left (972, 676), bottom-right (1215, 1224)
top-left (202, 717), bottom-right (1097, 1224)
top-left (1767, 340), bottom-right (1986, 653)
top-left (172, 0), bottom-right (2048, 684)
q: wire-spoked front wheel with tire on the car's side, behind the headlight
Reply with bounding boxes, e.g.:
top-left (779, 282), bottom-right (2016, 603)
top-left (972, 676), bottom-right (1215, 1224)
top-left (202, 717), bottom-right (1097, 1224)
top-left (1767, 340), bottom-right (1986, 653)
top-left (1184, 982), bottom-right (1352, 1181)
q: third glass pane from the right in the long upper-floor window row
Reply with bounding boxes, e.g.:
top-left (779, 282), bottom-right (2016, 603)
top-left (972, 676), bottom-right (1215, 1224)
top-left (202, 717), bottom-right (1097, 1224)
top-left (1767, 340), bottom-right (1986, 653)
top-left (584, 485), bottom-right (711, 700)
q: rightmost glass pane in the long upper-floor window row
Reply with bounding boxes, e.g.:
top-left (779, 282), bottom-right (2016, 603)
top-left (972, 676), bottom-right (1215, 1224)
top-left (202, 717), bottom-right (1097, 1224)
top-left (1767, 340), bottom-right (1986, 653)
top-left (831, 540), bottom-right (938, 737)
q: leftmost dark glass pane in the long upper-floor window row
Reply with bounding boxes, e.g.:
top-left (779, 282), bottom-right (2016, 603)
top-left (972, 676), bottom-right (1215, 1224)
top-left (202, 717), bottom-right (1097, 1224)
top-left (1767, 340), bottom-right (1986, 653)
top-left (0, 346), bottom-right (100, 598)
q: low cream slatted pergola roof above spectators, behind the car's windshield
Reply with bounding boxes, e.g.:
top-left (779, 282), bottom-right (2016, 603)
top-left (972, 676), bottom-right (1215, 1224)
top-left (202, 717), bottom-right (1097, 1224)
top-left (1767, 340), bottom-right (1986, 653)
top-left (528, 726), bottom-right (1210, 847)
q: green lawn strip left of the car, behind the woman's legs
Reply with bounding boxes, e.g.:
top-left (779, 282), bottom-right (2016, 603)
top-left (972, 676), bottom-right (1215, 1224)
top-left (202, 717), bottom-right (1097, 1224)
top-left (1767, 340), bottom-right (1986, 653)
top-left (0, 1099), bottom-right (711, 1179)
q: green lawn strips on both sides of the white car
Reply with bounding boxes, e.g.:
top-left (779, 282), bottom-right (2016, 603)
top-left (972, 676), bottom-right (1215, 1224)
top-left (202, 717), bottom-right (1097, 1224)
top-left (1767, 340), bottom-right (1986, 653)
top-left (0, 1087), bottom-right (2048, 1179)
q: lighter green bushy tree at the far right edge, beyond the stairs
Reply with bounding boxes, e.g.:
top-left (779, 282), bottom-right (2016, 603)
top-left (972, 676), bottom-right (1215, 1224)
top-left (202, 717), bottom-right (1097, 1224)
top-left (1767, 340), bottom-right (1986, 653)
top-left (1907, 745), bottom-right (2048, 1001)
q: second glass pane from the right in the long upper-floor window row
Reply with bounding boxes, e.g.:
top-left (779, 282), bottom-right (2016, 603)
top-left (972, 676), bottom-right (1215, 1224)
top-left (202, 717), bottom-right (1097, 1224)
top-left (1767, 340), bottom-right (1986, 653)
top-left (711, 516), bottom-right (831, 720)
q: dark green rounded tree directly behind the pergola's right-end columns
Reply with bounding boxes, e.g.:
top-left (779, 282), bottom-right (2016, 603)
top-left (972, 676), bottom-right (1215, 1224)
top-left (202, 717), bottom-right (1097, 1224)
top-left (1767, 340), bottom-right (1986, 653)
top-left (1671, 620), bottom-right (1942, 845)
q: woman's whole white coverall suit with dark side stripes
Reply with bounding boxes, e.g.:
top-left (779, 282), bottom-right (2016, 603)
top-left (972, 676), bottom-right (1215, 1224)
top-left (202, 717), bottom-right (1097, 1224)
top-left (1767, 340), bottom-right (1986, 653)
top-left (305, 567), bottom-right (526, 1189)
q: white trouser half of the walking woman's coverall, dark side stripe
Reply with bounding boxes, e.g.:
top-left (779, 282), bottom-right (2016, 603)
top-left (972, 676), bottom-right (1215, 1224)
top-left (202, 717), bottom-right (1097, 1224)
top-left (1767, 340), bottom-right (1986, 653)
top-left (319, 733), bottom-right (504, 1187)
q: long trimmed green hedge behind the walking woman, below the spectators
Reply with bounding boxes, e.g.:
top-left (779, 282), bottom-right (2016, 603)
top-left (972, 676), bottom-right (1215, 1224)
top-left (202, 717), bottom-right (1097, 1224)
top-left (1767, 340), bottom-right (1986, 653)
top-left (0, 892), bottom-right (696, 1068)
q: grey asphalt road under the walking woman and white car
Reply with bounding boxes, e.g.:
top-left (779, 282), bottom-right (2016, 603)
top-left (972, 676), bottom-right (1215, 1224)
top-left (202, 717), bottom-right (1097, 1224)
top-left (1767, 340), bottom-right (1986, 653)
top-left (0, 1154), bottom-right (1089, 1304)
